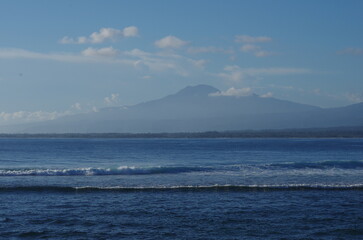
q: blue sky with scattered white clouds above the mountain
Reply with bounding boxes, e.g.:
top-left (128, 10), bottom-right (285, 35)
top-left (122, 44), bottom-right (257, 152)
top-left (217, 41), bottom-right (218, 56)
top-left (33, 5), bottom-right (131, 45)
top-left (0, 0), bottom-right (363, 125)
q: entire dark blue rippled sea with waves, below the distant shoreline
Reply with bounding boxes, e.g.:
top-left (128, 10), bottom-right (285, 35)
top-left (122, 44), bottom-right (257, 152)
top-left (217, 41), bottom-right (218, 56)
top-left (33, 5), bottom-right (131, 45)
top-left (0, 139), bottom-right (363, 239)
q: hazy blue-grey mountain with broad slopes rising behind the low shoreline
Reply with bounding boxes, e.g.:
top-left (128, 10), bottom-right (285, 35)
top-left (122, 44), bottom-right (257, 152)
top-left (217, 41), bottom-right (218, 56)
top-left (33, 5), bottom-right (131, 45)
top-left (0, 85), bottom-right (363, 133)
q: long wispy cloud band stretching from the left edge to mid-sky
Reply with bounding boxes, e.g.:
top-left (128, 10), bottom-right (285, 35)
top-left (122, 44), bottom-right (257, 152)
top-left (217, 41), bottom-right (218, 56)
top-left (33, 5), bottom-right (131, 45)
top-left (0, 47), bottom-right (203, 76)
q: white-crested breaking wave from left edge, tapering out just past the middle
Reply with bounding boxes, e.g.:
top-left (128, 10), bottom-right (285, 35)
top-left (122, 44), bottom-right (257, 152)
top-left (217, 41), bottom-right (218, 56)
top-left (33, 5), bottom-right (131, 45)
top-left (0, 166), bottom-right (208, 176)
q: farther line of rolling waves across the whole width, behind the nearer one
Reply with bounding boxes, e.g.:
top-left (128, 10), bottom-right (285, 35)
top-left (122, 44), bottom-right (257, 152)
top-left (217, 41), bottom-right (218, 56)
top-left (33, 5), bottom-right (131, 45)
top-left (0, 161), bottom-right (363, 177)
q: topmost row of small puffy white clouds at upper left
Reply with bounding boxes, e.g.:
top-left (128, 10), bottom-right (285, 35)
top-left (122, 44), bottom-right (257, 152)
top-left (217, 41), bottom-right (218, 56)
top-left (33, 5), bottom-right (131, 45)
top-left (59, 26), bottom-right (138, 44)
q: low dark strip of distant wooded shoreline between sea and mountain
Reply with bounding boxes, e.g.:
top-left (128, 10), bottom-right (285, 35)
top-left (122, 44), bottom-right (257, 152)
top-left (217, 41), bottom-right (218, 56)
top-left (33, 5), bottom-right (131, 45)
top-left (0, 127), bottom-right (363, 138)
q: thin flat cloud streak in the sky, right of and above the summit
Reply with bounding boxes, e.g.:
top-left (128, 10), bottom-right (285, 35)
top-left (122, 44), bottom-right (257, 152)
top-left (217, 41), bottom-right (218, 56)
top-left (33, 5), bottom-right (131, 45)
top-left (217, 65), bottom-right (311, 82)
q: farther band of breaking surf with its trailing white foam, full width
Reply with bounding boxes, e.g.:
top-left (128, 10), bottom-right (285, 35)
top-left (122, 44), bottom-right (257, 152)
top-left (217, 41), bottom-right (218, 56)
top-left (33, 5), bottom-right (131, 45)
top-left (0, 161), bottom-right (363, 177)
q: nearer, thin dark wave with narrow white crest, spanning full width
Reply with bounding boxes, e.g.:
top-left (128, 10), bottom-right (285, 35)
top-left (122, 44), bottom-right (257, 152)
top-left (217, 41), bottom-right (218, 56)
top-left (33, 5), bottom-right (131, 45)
top-left (0, 184), bottom-right (363, 193)
